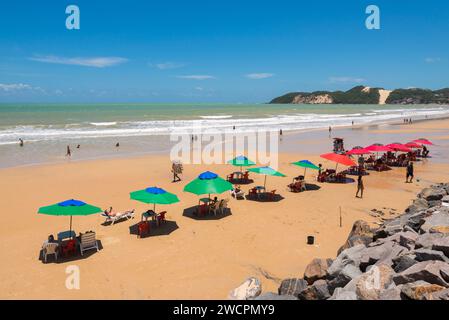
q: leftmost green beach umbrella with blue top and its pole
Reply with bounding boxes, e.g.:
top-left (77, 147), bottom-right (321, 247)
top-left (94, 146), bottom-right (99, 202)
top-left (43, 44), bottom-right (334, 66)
top-left (37, 199), bottom-right (103, 233)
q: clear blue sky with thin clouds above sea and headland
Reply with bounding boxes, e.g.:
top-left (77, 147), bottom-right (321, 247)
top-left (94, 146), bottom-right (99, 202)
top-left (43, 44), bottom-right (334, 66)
top-left (0, 0), bottom-right (449, 103)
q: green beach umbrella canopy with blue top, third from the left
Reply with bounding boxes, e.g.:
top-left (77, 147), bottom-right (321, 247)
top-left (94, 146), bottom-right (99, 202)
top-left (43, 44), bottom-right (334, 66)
top-left (184, 171), bottom-right (233, 198)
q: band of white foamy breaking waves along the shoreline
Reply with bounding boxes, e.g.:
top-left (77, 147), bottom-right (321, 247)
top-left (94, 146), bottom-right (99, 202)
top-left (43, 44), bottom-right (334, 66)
top-left (0, 106), bottom-right (449, 144)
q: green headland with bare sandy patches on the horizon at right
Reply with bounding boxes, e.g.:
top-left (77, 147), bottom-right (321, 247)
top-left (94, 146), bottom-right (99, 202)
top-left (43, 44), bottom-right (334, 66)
top-left (270, 86), bottom-right (449, 104)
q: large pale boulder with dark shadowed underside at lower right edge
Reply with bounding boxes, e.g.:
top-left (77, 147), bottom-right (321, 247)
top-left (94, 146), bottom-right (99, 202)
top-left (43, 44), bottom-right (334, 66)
top-left (393, 261), bottom-right (449, 287)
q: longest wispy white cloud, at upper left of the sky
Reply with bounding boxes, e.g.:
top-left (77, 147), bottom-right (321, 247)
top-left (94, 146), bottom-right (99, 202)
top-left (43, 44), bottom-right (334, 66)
top-left (29, 56), bottom-right (128, 68)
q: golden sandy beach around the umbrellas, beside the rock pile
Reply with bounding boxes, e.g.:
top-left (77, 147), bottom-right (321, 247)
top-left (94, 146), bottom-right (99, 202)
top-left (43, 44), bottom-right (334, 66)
top-left (0, 120), bottom-right (449, 299)
